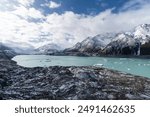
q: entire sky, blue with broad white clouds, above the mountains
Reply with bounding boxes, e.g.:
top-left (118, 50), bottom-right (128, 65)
top-left (0, 0), bottom-right (150, 48)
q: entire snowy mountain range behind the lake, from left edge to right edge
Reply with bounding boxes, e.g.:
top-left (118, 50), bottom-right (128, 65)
top-left (0, 24), bottom-right (150, 57)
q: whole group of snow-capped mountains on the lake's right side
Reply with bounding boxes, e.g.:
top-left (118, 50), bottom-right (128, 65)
top-left (65, 24), bottom-right (150, 55)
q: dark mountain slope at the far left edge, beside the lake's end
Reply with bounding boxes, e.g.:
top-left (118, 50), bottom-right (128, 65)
top-left (0, 43), bottom-right (16, 59)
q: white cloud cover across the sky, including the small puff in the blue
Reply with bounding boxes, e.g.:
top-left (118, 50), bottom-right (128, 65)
top-left (0, 0), bottom-right (150, 47)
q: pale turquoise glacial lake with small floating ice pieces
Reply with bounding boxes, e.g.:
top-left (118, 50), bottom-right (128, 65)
top-left (13, 55), bottom-right (150, 78)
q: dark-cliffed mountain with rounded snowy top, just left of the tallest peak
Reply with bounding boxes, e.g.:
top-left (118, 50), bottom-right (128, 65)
top-left (102, 33), bottom-right (141, 55)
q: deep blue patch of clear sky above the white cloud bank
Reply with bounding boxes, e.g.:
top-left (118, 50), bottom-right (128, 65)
top-left (34, 0), bottom-right (129, 15)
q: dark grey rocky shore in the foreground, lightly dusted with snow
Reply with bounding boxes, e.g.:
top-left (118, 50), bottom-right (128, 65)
top-left (0, 59), bottom-right (150, 100)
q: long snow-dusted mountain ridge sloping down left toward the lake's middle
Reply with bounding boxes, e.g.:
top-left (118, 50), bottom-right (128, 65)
top-left (65, 33), bottom-right (115, 53)
